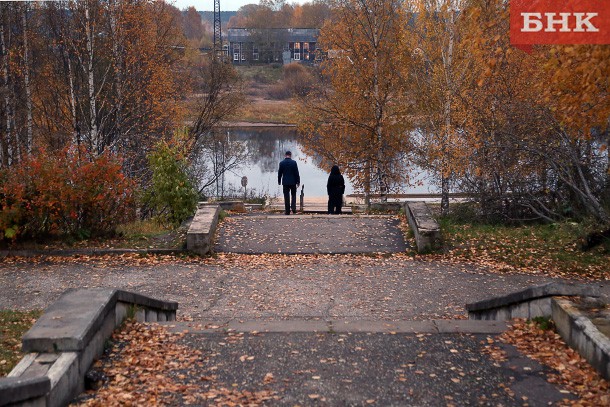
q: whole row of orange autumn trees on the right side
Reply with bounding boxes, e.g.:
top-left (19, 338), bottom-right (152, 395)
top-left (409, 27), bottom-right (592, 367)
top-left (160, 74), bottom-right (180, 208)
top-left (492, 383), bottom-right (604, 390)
top-left (300, 0), bottom-right (610, 231)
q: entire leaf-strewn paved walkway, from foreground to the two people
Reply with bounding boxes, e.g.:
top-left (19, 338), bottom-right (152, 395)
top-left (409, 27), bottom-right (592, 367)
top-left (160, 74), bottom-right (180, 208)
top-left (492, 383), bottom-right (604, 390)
top-left (0, 216), bottom-right (610, 406)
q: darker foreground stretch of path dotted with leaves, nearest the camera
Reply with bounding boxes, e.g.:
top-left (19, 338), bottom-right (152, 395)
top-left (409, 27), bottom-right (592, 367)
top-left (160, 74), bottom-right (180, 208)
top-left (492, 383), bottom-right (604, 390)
top-left (159, 332), bottom-right (573, 406)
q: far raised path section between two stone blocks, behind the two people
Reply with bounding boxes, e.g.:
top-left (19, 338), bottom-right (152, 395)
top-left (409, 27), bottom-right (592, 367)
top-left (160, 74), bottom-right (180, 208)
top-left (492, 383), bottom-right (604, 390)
top-left (215, 215), bottom-right (407, 254)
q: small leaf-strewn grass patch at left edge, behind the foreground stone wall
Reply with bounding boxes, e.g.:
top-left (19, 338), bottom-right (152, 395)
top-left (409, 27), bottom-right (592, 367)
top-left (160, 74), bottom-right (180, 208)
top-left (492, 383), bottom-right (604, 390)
top-left (0, 310), bottom-right (42, 376)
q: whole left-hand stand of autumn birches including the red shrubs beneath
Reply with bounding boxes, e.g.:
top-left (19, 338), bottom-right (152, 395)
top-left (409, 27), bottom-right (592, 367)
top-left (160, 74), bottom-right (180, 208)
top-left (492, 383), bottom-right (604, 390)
top-left (0, 0), bottom-right (241, 238)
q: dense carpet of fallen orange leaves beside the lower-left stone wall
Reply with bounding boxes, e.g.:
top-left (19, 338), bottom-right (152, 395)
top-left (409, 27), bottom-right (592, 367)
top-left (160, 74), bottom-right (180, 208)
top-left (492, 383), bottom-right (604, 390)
top-left (76, 322), bottom-right (278, 406)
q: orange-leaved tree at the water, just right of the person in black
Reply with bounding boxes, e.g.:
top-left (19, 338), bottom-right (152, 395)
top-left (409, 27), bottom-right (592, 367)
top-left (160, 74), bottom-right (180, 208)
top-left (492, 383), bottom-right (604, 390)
top-left (299, 0), bottom-right (412, 204)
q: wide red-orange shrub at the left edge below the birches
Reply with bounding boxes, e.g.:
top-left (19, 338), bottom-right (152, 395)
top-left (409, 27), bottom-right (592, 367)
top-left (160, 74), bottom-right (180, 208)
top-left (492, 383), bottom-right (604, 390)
top-left (0, 148), bottom-right (134, 239)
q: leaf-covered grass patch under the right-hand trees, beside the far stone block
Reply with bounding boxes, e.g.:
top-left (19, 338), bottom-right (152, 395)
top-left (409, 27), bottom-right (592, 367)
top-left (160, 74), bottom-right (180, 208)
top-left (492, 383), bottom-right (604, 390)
top-left (439, 218), bottom-right (610, 277)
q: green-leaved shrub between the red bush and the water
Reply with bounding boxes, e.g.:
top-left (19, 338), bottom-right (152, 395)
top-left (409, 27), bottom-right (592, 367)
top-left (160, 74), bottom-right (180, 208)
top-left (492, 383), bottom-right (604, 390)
top-left (145, 137), bottom-right (198, 226)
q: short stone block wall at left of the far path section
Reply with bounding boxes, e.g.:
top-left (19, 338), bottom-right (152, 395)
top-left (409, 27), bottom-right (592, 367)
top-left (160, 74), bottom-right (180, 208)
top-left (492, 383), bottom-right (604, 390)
top-left (186, 205), bottom-right (220, 256)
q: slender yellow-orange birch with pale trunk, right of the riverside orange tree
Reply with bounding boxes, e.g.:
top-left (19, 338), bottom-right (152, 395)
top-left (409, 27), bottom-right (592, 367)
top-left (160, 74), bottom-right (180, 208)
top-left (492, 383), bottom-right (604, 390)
top-left (405, 0), bottom-right (472, 214)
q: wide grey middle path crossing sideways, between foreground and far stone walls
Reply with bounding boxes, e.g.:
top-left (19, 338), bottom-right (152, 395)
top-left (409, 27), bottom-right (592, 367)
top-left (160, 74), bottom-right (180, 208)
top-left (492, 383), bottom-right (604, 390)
top-left (0, 254), bottom-right (610, 322)
